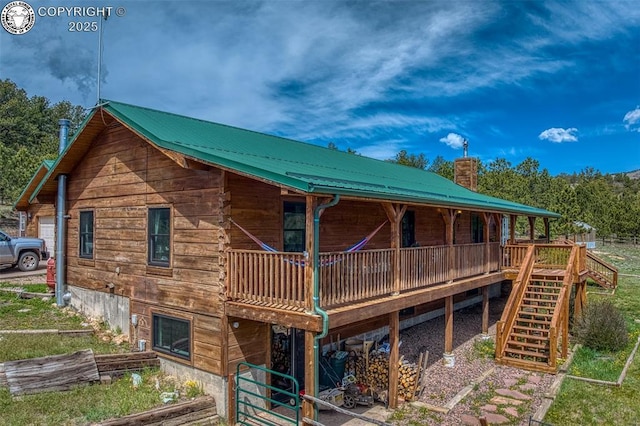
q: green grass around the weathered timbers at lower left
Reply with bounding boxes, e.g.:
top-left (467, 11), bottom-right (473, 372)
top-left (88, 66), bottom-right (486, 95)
top-left (0, 283), bottom-right (208, 426)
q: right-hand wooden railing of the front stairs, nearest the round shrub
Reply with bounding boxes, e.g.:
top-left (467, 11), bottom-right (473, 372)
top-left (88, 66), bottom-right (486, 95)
top-left (548, 245), bottom-right (580, 369)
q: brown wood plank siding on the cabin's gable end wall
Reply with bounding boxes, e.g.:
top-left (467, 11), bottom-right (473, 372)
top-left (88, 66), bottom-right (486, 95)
top-left (67, 126), bottom-right (226, 374)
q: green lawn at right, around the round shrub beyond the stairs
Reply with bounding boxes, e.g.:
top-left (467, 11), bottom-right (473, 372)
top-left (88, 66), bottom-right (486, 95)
top-left (544, 246), bottom-right (640, 426)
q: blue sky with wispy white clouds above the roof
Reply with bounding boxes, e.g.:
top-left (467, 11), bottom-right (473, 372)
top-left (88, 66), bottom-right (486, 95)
top-left (0, 0), bottom-right (640, 175)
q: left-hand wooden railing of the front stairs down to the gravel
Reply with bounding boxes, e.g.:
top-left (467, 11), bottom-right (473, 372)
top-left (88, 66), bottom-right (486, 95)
top-left (496, 244), bottom-right (535, 360)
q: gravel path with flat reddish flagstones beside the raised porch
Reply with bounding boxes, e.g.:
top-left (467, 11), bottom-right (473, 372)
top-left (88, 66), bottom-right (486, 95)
top-left (382, 298), bottom-right (556, 426)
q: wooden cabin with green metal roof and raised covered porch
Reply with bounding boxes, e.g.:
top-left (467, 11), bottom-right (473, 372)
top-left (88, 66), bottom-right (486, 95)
top-left (17, 101), bottom-right (558, 419)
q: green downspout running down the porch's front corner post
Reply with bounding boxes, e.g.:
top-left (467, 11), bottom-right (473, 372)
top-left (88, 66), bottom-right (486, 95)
top-left (313, 194), bottom-right (340, 419)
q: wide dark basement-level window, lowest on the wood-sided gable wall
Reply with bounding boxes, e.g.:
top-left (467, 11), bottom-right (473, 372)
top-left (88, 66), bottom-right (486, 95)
top-left (153, 314), bottom-right (191, 359)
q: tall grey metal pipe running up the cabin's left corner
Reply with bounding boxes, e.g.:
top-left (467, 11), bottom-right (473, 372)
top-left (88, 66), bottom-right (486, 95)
top-left (56, 118), bottom-right (71, 307)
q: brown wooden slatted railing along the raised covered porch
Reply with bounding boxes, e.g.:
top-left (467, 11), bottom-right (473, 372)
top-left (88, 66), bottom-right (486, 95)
top-left (227, 243), bottom-right (501, 308)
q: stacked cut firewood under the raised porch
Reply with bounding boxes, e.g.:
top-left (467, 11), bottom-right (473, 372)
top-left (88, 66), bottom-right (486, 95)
top-left (365, 352), bottom-right (420, 401)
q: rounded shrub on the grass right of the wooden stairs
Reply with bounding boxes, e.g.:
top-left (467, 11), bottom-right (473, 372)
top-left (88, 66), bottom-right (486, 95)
top-left (573, 300), bottom-right (629, 352)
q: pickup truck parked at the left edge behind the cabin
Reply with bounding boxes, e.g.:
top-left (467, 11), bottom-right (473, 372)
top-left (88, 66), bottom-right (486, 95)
top-left (0, 231), bottom-right (49, 272)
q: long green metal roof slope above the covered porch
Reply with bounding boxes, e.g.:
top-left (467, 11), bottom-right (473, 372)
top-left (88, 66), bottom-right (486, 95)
top-left (63, 101), bottom-right (560, 217)
